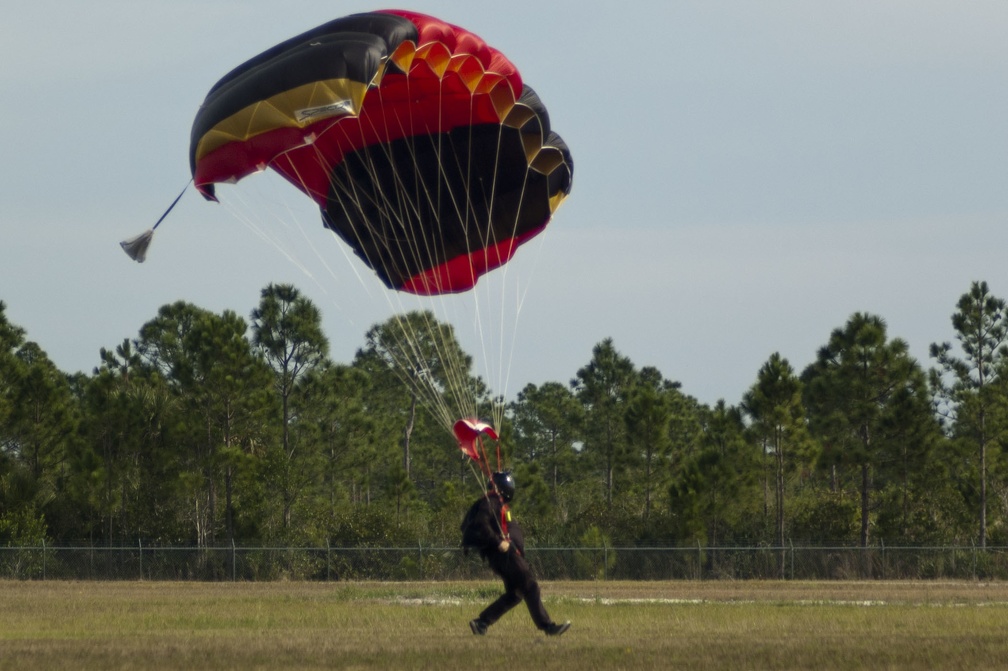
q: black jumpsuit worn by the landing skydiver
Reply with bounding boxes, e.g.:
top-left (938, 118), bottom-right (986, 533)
top-left (462, 493), bottom-right (553, 631)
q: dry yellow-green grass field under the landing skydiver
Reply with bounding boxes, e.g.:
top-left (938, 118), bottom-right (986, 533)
top-left (0, 580), bottom-right (1008, 671)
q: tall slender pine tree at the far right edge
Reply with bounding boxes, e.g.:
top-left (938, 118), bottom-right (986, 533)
top-left (930, 282), bottom-right (1008, 547)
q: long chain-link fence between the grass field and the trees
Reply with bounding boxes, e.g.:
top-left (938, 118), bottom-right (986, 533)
top-left (0, 542), bottom-right (1008, 580)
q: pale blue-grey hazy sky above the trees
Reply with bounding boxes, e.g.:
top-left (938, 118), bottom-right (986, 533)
top-left (0, 0), bottom-right (1008, 404)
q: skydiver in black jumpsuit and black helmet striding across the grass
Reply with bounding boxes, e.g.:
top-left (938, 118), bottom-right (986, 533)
top-left (462, 472), bottom-right (571, 636)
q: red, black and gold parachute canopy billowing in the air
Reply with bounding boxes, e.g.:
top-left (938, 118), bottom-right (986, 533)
top-left (190, 10), bottom-right (573, 294)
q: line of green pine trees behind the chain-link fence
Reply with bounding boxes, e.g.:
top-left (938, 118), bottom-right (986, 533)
top-left (0, 282), bottom-right (1008, 547)
